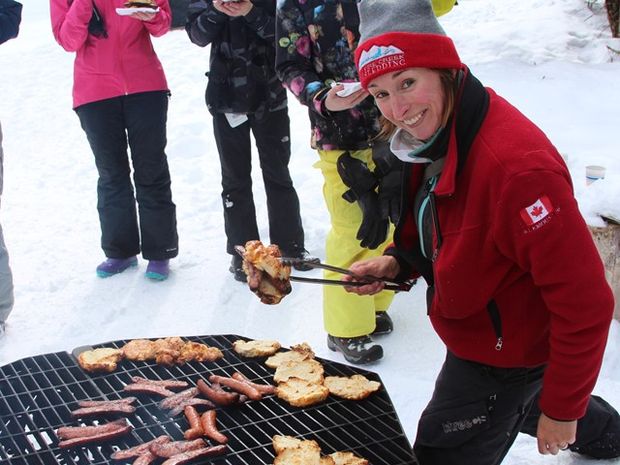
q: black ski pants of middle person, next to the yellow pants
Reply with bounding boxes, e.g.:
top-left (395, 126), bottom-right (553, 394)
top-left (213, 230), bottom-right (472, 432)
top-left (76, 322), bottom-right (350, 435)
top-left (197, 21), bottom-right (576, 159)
top-left (213, 108), bottom-right (304, 255)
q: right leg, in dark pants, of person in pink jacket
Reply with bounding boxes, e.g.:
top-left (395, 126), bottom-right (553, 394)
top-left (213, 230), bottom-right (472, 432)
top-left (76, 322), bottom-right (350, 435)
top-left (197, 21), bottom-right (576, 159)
top-left (123, 91), bottom-right (179, 260)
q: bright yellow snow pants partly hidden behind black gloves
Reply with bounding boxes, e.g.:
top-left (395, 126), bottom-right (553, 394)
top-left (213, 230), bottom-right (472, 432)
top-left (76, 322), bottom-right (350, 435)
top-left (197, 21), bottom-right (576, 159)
top-left (314, 149), bottom-right (394, 337)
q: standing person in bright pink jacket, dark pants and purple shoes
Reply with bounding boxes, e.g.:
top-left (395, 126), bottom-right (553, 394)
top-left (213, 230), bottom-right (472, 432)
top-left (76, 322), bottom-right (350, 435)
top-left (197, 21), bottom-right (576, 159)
top-left (50, 0), bottom-right (178, 280)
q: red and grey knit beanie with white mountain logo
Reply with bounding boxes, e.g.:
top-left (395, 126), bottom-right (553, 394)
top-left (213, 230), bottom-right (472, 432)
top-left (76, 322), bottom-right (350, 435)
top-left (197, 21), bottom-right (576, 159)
top-left (355, 0), bottom-right (463, 88)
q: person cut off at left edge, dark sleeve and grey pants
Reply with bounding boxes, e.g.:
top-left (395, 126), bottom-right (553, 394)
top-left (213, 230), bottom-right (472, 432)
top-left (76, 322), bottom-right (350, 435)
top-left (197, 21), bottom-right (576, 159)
top-left (0, 0), bottom-right (22, 335)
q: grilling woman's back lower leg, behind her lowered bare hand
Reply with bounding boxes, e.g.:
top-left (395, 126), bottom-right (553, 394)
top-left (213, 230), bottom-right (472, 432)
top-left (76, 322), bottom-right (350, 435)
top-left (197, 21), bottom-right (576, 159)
top-left (521, 393), bottom-right (620, 459)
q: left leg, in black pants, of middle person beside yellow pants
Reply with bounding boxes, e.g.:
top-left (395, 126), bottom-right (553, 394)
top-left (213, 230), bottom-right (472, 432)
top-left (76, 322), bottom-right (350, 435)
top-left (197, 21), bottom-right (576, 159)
top-left (213, 113), bottom-right (260, 257)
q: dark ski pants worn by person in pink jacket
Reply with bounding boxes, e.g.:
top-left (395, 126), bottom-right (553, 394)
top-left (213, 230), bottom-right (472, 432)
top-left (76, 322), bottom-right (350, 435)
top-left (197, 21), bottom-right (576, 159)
top-left (75, 91), bottom-right (178, 260)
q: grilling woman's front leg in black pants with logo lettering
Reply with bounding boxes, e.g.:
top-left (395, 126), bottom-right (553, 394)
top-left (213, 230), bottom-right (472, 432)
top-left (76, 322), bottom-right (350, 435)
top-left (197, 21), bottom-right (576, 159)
top-left (413, 353), bottom-right (544, 465)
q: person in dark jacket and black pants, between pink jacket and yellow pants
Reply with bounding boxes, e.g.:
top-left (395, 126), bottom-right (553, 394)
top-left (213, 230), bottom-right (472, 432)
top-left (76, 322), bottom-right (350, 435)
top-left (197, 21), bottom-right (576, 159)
top-left (186, 0), bottom-right (306, 282)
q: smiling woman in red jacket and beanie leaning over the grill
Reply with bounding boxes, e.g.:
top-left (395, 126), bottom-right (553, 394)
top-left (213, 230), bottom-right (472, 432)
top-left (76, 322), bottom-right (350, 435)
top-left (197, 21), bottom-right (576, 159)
top-left (347, 0), bottom-right (620, 465)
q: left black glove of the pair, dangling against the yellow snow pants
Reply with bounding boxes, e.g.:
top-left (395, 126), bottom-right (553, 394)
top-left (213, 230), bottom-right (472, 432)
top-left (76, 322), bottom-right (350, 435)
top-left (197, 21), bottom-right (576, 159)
top-left (337, 152), bottom-right (389, 249)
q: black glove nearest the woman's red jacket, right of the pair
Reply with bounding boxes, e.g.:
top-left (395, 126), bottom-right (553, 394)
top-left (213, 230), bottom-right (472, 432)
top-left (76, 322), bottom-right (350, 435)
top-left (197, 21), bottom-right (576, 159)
top-left (372, 142), bottom-right (404, 224)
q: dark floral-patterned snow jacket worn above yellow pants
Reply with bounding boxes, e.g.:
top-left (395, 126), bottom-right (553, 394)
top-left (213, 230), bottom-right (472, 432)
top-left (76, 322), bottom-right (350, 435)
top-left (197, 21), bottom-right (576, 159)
top-left (276, 0), bottom-right (379, 150)
